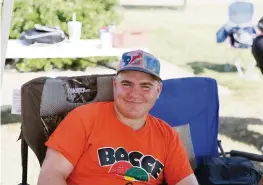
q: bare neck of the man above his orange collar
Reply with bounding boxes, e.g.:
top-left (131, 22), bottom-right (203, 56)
top-left (114, 106), bottom-right (147, 130)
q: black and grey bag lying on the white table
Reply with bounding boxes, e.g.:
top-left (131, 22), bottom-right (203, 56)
top-left (20, 24), bottom-right (67, 45)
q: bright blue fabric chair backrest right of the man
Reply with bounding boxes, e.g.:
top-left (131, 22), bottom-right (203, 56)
top-left (150, 77), bottom-right (219, 165)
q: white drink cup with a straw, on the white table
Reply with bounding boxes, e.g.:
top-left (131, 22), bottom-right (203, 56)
top-left (68, 21), bottom-right (82, 41)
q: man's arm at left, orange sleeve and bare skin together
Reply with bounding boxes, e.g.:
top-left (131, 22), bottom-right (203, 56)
top-left (38, 107), bottom-right (94, 185)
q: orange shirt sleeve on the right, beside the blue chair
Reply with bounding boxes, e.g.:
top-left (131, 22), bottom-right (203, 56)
top-left (164, 129), bottom-right (193, 185)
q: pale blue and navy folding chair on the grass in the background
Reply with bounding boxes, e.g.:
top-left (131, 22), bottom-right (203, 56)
top-left (217, 0), bottom-right (256, 76)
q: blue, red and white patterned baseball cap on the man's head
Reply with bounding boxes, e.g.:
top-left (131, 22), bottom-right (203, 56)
top-left (117, 50), bottom-right (161, 80)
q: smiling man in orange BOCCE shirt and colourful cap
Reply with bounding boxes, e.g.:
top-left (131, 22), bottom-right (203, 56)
top-left (38, 50), bottom-right (198, 185)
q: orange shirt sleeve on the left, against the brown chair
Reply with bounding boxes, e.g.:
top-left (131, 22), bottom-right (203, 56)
top-left (45, 107), bottom-right (91, 167)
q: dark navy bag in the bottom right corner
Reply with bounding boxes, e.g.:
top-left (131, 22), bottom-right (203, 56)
top-left (195, 141), bottom-right (262, 185)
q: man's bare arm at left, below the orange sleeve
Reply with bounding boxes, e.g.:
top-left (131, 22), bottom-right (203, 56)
top-left (37, 148), bottom-right (73, 185)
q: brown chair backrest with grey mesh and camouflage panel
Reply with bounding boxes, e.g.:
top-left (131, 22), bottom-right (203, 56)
top-left (21, 75), bottom-right (113, 165)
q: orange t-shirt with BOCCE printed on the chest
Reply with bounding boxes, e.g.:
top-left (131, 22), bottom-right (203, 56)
top-left (46, 102), bottom-right (193, 185)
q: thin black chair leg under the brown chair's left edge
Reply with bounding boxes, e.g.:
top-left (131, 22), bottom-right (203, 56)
top-left (19, 134), bottom-right (29, 185)
